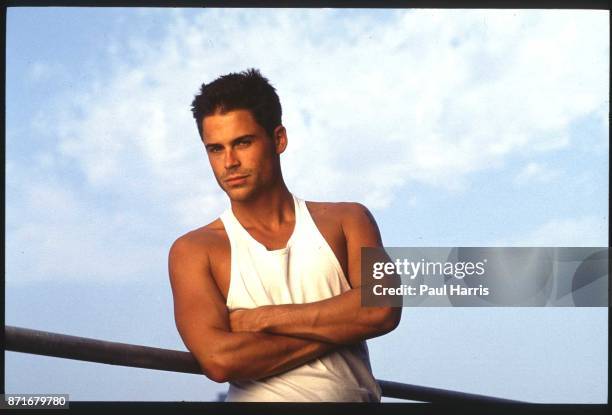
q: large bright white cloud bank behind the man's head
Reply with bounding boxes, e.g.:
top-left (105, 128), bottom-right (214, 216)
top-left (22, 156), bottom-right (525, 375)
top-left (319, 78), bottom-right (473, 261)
top-left (9, 9), bottom-right (609, 284)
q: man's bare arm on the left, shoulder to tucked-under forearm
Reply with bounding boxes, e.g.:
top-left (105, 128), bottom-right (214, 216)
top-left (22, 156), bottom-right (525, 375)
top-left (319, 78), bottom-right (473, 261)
top-left (168, 238), bottom-right (337, 382)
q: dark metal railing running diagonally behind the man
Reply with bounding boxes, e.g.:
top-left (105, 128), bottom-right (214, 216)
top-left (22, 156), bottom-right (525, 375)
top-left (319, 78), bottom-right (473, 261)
top-left (4, 326), bottom-right (524, 403)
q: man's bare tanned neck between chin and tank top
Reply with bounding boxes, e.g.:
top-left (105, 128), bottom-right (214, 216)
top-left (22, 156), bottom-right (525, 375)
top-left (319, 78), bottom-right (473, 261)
top-left (231, 183), bottom-right (295, 229)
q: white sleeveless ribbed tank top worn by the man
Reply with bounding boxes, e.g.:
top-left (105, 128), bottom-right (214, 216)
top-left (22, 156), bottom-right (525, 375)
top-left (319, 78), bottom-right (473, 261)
top-left (221, 196), bottom-right (381, 402)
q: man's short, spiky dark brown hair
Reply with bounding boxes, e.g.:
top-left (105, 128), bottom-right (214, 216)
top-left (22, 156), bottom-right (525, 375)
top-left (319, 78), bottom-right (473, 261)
top-left (191, 68), bottom-right (282, 139)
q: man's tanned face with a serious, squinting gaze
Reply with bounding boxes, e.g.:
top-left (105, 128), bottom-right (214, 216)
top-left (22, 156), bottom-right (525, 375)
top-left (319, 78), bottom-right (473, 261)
top-left (202, 110), bottom-right (286, 201)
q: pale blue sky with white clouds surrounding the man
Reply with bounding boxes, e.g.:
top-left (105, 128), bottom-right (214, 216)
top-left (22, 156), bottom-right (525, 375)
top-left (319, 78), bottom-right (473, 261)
top-left (5, 8), bottom-right (609, 402)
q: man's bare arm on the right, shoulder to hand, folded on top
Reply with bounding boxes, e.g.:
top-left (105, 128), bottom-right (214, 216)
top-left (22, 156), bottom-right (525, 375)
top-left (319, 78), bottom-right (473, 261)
top-left (230, 204), bottom-right (401, 344)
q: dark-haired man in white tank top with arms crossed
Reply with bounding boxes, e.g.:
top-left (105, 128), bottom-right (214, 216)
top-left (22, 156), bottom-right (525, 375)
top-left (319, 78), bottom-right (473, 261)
top-left (168, 69), bottom-right (401, 402)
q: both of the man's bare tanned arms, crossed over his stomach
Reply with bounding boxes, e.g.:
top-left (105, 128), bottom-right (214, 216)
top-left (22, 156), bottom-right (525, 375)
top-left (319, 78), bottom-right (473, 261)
top-left (169, 204), bottom-right (401, 382)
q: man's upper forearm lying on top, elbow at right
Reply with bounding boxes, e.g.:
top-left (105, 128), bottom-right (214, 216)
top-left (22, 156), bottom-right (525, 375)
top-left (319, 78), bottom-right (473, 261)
top-left (238, 289), bottom-right (399, 344)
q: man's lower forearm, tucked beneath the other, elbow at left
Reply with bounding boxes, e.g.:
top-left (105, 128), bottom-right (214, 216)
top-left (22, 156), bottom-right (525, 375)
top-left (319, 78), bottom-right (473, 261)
top-left (201, 330), bottom-right (338, 381)
